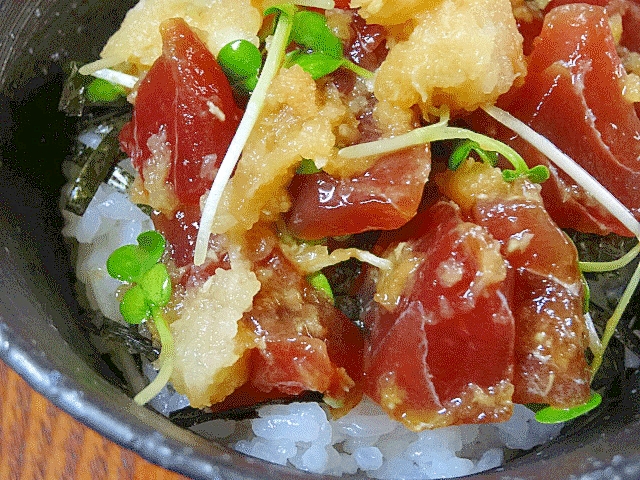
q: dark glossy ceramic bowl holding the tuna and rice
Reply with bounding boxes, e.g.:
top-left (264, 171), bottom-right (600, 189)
top-left (0, 0), bottom-right (640, 479)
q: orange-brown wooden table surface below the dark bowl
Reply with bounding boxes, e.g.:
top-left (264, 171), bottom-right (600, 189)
top-left (0, 361), bottom-right (186, 480)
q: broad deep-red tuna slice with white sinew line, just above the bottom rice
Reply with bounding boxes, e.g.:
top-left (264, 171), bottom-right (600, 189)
top-left (364, 202), bottom-right (514, 430)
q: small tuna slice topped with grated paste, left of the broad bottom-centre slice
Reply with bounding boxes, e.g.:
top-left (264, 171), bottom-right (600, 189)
top-left (242, 250), bottom-right (364, 408)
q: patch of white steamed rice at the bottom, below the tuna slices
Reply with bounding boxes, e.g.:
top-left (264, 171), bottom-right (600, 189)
top-left (195, 399), bottom-right (562, 479)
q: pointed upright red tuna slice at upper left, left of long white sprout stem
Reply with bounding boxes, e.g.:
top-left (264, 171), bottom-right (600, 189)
top-left (120, 18), bottom-right (242, 205)
